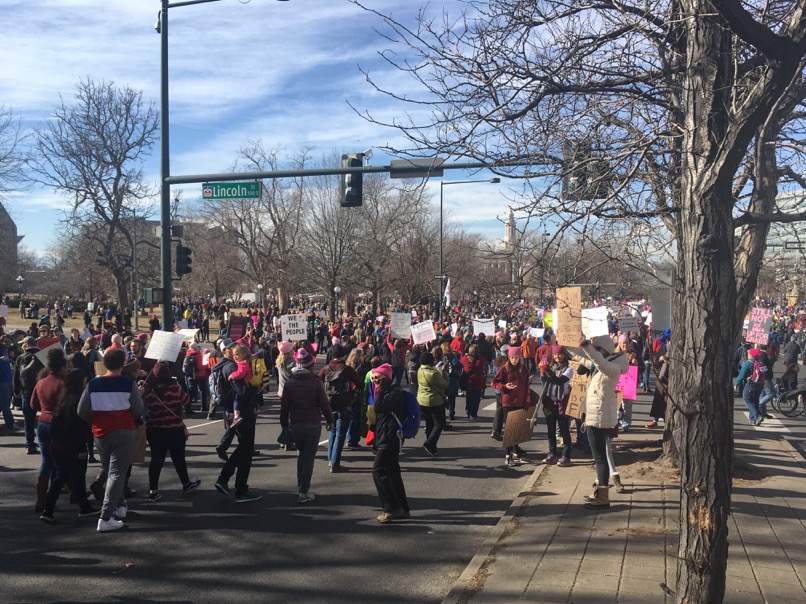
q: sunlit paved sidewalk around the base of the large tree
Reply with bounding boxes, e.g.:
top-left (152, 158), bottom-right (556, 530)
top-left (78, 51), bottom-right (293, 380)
top-left (443, 399), bottom-right (806, 604)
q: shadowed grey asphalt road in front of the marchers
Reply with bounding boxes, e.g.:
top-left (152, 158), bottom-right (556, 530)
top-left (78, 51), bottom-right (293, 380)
top-left (0, 383), bottom-right (545, 604)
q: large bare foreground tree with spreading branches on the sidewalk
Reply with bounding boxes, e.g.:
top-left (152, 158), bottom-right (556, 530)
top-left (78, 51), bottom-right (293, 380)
top-left (357, 0), bottom-right (806, 602)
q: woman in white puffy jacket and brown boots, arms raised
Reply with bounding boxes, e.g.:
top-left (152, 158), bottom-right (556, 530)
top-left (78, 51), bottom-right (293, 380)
top-left (579, 334), bottom-right (629, 509)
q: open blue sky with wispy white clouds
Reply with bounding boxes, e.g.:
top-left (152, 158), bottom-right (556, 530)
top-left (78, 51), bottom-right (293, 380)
top-left (0, 0), bottom-right (512, 254)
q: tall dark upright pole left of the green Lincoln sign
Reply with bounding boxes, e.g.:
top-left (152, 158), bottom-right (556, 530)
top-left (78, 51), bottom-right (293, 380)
top-left (154, 0), bottom-right (287, 331)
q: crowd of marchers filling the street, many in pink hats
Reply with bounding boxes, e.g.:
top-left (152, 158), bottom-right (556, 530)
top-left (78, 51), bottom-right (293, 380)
top-left (0, 294), bottom-right (802, 532)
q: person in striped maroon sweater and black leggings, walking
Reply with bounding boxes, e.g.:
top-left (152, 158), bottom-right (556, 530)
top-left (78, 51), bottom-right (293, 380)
top-left (143, 363), bottom-right (201, 502)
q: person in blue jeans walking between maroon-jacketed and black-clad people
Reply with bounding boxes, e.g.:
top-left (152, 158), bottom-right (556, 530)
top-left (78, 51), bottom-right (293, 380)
top-left (319, 344), bottom-right (364, 474)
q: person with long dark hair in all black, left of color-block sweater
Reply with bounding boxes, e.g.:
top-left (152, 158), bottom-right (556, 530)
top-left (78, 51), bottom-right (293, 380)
top-left (39, 369), bottom-right (100, 523)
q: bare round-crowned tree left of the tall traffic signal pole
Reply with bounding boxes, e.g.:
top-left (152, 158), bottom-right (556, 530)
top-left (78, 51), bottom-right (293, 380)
top-left (28, 79), bottom-right (158, 307)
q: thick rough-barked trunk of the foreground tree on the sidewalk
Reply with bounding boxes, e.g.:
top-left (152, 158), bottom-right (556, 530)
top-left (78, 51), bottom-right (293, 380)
top-left (667, 8), bottom-right (737, 602)
